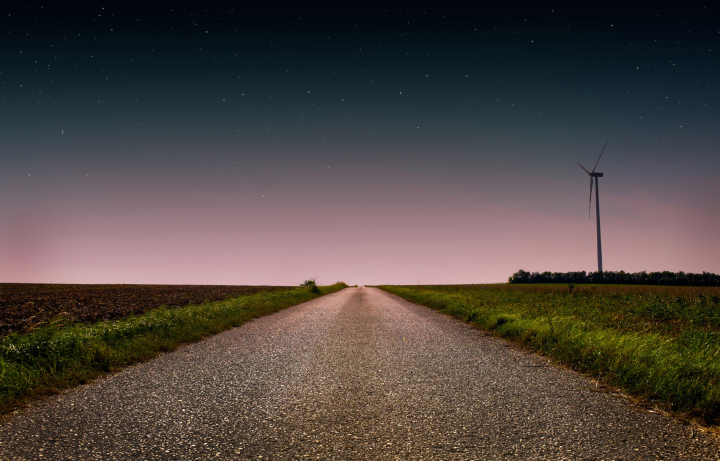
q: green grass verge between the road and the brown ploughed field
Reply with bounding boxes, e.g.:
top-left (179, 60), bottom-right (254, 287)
top-left (0, 283), bottom-right (347, 412)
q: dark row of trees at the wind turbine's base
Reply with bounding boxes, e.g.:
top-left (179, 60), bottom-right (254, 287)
top-left (508, 269), bottom-right (720, 287)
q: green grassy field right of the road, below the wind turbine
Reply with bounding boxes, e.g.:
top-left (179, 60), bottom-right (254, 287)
top-left (380, 284), bottom-right (720, 424)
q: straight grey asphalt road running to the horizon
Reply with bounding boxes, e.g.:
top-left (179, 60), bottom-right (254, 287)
top-left (0, 288), bottom-right (720, 460)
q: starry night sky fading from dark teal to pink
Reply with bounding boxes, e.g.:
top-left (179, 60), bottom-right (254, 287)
top-left (0, 1), bottom-right (720, 285)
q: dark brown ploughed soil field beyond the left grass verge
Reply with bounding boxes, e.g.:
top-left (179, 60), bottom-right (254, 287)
top-left (0, 283), bottom-right (293, 336)
